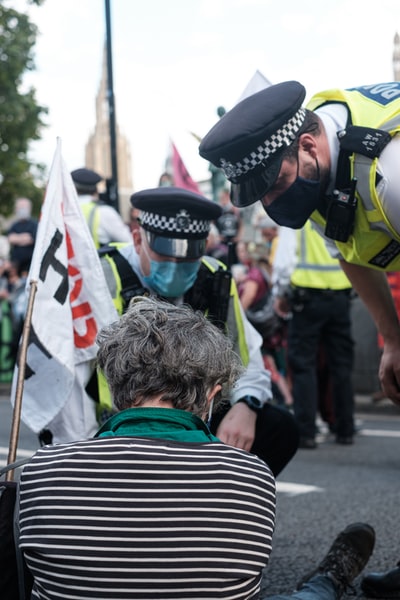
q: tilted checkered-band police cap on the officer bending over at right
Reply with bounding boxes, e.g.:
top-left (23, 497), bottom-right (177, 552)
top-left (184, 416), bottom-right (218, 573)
top-left (199, 81), bottom-right (306, 207)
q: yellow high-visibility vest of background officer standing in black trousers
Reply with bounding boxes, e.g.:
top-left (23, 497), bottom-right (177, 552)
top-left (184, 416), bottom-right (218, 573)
top-left (290, 221), bottom-right (351, 290)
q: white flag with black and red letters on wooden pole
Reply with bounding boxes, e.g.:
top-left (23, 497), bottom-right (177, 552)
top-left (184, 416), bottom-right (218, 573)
top-left (12, 140), bottom-right (118, 433)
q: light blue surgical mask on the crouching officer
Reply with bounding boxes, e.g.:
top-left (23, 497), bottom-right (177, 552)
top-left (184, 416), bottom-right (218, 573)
top-left (143, 241), bottom-right (200, 298)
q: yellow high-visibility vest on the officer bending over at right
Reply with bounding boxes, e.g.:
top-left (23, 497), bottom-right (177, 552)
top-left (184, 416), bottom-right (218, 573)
top-left (307, 82), bottom-right (400, 271)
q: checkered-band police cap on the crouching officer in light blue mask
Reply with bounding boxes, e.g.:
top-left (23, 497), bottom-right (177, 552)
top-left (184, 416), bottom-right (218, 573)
top-left (131, 186), bottom-right (221, 259)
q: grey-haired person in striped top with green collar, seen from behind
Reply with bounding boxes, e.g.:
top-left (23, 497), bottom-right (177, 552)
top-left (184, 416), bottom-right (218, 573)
top-left (19, 298), bottom-right (275, 600)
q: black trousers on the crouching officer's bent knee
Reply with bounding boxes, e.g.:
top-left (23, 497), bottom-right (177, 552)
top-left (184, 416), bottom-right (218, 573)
top-left (210, 404), bottom-right (299, 477)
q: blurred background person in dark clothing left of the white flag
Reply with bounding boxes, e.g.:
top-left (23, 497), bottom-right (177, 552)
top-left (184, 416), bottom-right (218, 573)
top-left (7, 198), bottom-right (38, 275)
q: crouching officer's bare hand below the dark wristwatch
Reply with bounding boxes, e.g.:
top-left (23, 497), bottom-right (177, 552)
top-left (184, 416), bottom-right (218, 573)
top-left (216, 402), bottom-right (257, 452)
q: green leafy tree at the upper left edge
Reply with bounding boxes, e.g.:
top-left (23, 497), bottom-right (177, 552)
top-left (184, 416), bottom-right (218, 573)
top-left (0, 0), bottom-right (47, 215)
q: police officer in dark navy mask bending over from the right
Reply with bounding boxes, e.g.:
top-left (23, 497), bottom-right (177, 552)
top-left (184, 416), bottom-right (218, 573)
top-left (199, 81), bottom-right (400, 404)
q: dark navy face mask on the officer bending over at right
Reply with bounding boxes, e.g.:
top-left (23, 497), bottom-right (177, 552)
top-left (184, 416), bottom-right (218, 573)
top-left (264, 162), bottom-right (321, 229)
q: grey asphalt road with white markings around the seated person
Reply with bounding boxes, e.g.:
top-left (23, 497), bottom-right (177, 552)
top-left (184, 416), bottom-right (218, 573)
top-left (0, 386), bottom-right (400, 599)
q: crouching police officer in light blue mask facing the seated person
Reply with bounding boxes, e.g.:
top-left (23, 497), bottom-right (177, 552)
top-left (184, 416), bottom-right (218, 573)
top-left (95, 187), bottom-right (298, 475)
